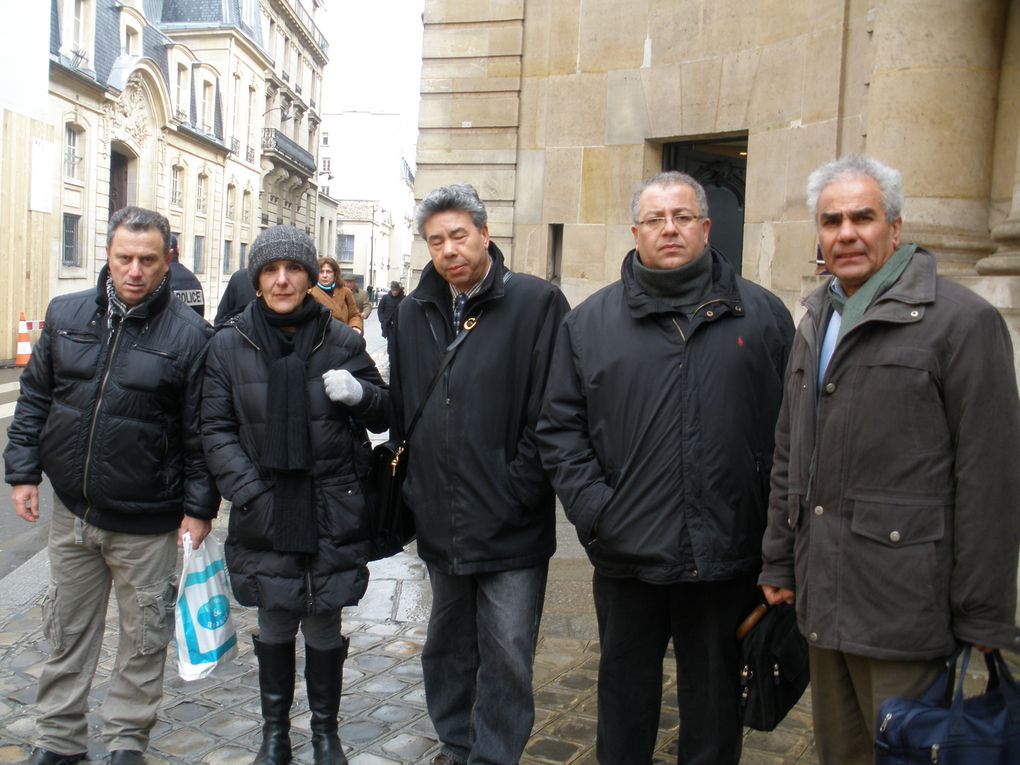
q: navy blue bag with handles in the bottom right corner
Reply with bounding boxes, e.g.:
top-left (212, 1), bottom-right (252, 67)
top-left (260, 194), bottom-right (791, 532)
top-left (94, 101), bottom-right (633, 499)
top-left (875, 646), bottom-right (1020, 765)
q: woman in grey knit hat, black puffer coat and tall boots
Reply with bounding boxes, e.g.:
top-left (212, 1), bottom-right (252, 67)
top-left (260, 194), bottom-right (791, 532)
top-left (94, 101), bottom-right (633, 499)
top-left (202, 225), bottom-right (389, 765)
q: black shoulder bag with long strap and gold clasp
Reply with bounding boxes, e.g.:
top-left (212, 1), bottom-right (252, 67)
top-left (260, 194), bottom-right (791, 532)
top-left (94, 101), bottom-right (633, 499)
top-left (356, 314), bottom-right (480, 560)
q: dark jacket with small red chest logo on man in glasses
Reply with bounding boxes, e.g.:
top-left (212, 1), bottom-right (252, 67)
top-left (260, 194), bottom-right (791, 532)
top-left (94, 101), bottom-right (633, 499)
top-left (538, 251), bottom-right (794, 583)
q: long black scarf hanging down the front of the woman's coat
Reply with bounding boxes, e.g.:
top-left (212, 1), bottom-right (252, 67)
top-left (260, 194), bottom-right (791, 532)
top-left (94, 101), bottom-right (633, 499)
top-left (252, 297), bottom-right (322, 553)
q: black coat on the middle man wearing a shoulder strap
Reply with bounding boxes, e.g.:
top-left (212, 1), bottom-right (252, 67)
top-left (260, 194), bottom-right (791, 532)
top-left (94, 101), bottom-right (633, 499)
top-left (390, 244), bottom-right (568, 574)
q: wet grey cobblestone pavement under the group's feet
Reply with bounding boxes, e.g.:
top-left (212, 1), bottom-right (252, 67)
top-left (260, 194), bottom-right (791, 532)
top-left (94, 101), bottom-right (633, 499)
top-left (0, 512), bottom-right (816, 765)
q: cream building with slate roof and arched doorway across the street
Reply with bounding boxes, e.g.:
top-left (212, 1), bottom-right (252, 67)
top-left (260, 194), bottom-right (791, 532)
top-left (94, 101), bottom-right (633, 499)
top-left (0, 0), bottom-right (332, 358)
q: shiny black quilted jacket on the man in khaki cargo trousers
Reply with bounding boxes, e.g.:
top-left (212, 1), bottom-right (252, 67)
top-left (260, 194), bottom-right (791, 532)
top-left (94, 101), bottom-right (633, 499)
top-left (4, 266), bottom-right (219, 533)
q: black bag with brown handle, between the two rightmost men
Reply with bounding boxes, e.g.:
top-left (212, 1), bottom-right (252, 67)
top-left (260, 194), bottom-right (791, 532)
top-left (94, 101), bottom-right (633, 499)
top-left (736, 603), bottom-right (810, 730)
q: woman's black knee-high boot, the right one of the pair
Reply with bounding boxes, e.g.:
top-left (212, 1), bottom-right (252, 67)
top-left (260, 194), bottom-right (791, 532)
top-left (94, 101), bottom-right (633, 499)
top-left (305, 639), bottom-right (350, 765)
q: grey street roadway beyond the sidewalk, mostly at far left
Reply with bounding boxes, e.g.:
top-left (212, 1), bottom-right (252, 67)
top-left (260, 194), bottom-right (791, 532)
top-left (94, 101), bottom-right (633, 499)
top-left (0, 301), bottom-right (389, 578)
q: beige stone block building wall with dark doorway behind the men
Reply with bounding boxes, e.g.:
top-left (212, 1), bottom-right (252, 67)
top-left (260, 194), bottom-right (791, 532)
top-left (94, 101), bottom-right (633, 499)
top-left (414, 0), bottom-right (1020, 354)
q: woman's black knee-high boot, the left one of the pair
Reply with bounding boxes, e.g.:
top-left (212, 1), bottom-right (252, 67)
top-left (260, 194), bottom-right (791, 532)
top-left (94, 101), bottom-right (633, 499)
top-left (252, 635), bottom-right (295, 765)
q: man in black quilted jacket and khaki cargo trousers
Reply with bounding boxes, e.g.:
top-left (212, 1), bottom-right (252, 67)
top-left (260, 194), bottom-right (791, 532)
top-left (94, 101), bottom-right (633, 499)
top-left (4, 207), bottom-right (219, 765)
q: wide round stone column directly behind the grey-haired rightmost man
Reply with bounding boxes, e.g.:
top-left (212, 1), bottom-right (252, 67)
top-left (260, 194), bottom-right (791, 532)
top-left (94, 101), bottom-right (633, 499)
top-left (865, 0), bottom-right (1009, 275)
